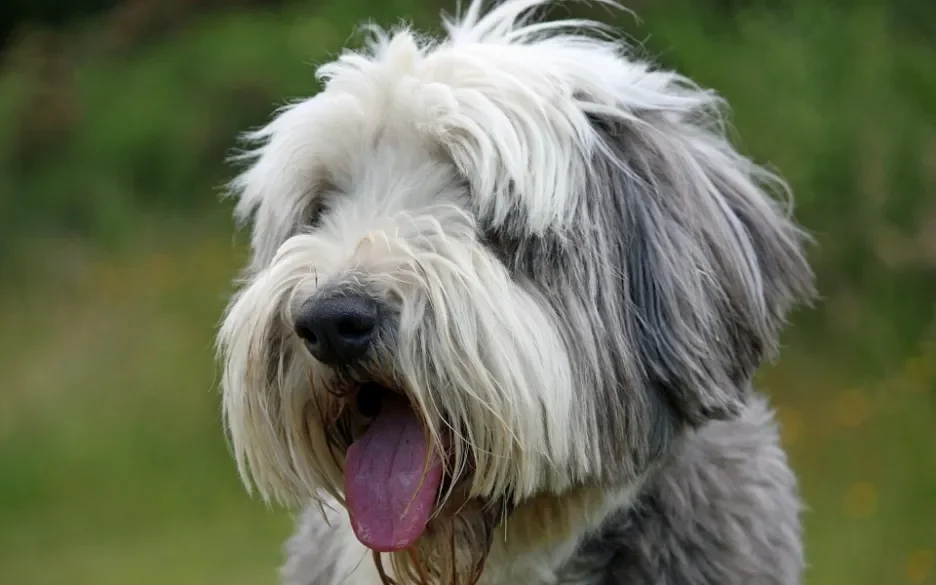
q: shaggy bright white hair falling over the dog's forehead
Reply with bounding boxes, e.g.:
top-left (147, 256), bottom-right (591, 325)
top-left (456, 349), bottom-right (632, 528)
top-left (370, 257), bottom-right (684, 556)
top-left (232, 13), bottom-right (652, 263)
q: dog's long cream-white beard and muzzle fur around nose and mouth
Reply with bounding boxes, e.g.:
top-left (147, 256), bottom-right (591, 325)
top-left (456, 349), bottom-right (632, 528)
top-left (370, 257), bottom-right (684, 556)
top-left (219, 209), bottom-right (589, 585)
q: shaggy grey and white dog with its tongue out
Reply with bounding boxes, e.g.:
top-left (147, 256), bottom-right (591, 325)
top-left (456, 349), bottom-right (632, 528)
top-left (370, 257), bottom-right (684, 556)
top-left (218, 0), bottom-right (815, 585)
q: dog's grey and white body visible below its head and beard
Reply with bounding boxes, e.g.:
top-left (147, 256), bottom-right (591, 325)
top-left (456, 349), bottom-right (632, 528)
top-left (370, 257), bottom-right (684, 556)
top-left (282, 396), bottom-right (803, 585)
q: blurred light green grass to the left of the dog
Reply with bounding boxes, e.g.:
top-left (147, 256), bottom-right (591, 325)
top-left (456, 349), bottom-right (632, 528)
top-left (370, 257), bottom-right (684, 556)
top-left (0, 230), bottom-right (288, 585)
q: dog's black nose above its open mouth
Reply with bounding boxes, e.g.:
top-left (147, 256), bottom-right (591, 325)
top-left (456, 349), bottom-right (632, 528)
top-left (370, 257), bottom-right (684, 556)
top-left (295, 295), bottom-right (380, 366)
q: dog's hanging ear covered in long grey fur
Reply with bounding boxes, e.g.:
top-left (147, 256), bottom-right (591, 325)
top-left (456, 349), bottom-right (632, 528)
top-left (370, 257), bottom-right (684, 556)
top-left (585, 112), bottom-right (814, 424)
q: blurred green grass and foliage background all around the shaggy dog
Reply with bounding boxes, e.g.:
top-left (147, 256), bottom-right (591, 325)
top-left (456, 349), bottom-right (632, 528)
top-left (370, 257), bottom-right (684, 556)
top-left (0, 0), bottom-right (936, 585)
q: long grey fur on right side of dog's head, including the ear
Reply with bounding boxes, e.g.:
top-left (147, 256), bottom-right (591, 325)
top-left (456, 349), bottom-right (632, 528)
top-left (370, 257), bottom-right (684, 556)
top-left (481, 106), bottom-right (814, 492)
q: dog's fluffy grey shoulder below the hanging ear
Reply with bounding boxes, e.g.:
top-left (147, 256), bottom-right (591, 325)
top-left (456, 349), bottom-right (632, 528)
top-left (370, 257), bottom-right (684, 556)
top-left (560, 398), bottom-right (803, 585)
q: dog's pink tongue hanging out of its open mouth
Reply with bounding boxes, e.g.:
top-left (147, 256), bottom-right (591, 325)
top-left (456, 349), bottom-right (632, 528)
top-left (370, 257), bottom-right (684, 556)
top-left (344, 399), bottom-right (442, 552)
